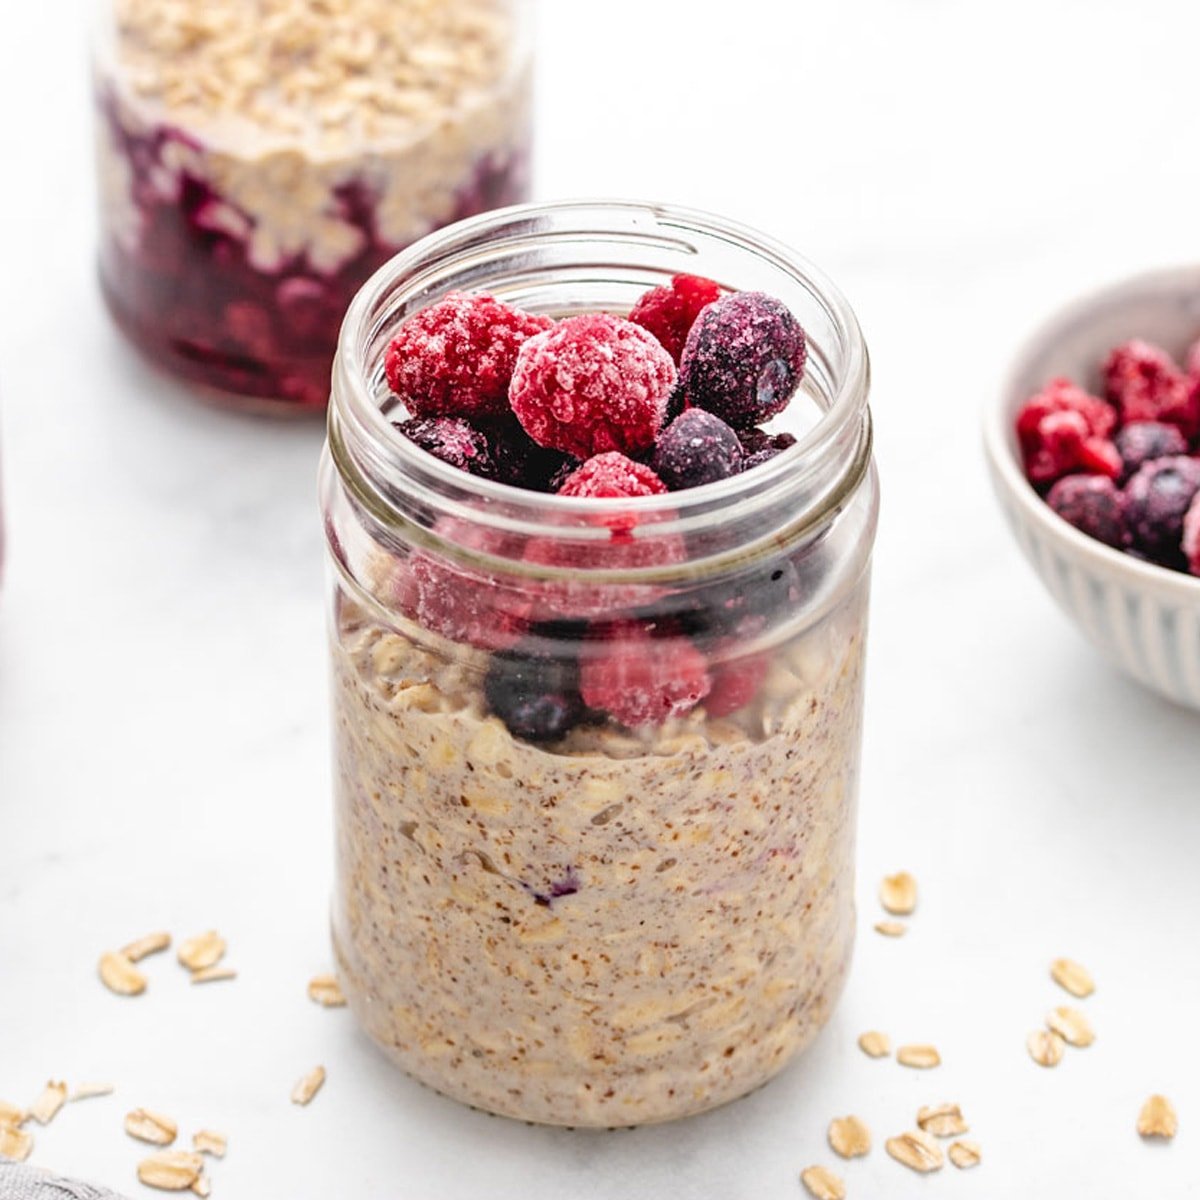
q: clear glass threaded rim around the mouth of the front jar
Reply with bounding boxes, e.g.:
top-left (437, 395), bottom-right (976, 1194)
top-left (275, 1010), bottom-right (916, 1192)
top-left (329, 199), bottom-right (871, 552)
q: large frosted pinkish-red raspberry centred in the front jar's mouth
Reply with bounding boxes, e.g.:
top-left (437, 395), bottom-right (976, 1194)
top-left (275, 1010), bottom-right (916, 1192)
top-left (509, 312), bottom-right (676, 458)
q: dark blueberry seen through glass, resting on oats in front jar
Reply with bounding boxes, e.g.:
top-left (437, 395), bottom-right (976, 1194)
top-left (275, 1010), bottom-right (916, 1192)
top-left (484, 638), bottom-right (583, 739)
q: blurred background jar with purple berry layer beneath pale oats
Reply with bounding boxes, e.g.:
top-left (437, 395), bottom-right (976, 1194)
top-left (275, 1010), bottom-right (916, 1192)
top-left (95, 0), bottom-right (532, 412)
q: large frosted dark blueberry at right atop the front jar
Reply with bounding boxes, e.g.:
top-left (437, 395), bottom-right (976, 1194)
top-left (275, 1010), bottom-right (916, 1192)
top-left (679, 292), bottom-right (808, 430)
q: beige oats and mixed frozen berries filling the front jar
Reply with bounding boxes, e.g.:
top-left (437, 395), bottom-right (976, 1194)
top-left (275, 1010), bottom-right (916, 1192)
top-left (326, 277), bottom-right (874, 1126)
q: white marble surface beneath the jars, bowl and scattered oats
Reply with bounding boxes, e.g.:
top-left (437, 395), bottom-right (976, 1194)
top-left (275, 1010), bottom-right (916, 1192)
top-left (0, 0), bottom-right (1200, 1200)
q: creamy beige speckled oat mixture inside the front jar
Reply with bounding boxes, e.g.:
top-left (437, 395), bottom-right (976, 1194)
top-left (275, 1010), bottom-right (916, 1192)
top-left (334, 586), bottom-right (865, 1126)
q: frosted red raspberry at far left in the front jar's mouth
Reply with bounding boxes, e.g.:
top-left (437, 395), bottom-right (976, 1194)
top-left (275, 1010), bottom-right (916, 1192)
top-left (384, 292), bottom-right (553, 416)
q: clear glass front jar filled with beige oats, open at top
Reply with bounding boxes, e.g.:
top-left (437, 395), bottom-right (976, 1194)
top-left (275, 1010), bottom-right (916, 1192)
top-left (322, 203), bottom-right (878, 1126)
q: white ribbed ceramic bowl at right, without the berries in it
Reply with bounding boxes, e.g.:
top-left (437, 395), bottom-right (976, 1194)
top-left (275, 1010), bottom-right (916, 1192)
top-left (984, 266), bottom-right (1200, 709)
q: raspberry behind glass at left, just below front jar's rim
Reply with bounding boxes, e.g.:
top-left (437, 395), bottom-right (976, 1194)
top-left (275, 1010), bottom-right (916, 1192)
top-left (391, 518), bottom-right (533, 650)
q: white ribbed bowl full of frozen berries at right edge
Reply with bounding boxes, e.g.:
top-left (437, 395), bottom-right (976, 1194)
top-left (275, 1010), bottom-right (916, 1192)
top-left (985, 266), bottom-right (1200, 709)
